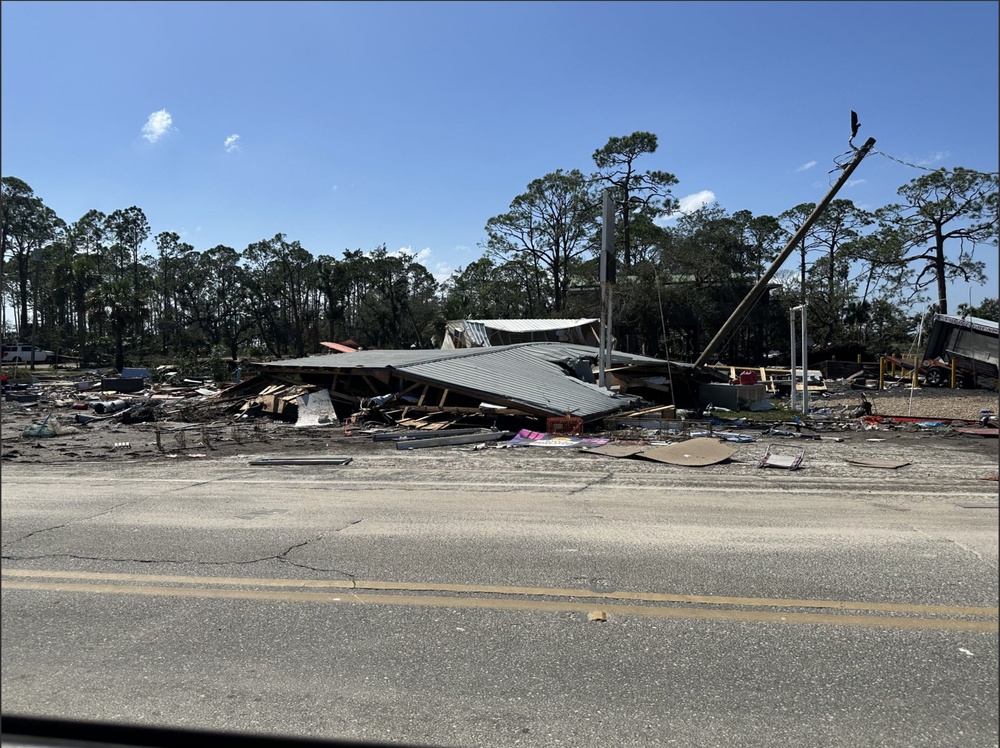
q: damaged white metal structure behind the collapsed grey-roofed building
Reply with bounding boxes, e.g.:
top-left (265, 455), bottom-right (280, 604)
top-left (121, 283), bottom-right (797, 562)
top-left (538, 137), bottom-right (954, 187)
top-left (441, 319), bottom-right (601, 349)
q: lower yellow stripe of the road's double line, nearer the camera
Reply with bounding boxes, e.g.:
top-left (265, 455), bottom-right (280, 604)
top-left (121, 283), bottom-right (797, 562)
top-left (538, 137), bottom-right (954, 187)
top-left (2, 580), bottom-right (997, 632)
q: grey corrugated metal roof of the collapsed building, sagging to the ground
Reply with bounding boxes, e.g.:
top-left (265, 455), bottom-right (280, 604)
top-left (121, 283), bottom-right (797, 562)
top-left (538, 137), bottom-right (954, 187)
top-left (258, 343), bottom-right (689, 419)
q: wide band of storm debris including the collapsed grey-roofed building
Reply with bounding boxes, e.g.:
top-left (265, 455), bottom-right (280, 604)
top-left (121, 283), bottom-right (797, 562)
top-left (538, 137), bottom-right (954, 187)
top-left (0, 343), bottom-right (998, 478)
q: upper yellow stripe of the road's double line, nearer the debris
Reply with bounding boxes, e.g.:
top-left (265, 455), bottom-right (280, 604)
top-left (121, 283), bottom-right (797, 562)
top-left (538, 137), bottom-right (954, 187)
top-left (0, 569), bottom-right (1000, 616)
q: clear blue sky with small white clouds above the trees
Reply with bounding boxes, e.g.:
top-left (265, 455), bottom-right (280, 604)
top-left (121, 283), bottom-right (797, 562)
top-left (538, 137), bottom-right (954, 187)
top-left (0, 0), bottom-right (1000, 307)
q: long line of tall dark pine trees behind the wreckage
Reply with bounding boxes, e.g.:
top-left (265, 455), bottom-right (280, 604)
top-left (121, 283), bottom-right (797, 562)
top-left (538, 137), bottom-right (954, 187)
top-left (0, 132), bottom-right (998, 369)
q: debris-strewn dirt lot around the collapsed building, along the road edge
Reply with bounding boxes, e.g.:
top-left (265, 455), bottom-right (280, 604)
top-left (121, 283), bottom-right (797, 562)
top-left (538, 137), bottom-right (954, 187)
top-left (0, 371), bottom-right (1000, 479)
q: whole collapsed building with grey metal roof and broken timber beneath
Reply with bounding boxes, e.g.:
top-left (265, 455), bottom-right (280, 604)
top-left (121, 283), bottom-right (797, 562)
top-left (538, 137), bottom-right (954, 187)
top-left (244, 342), bottom-right (726, 427)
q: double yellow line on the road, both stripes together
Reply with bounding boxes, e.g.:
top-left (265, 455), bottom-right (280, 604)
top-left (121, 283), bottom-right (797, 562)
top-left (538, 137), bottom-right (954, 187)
top-left (0, 569), bottom-right (998, 632)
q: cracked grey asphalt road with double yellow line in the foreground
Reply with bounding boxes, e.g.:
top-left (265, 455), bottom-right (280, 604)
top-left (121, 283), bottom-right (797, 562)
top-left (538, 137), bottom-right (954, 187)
top-left (2, 445), bottom-right (998, 748)
